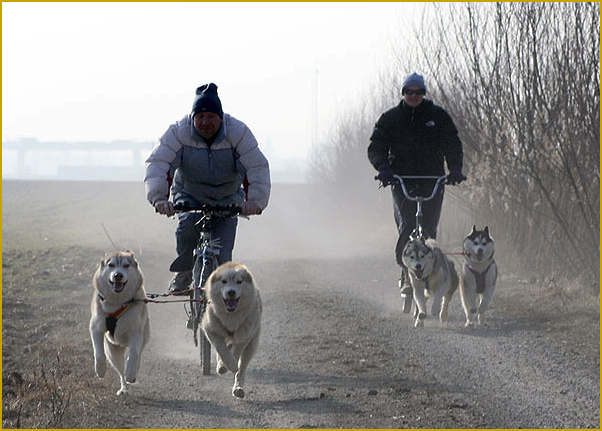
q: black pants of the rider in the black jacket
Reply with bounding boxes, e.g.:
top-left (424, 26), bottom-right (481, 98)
top-left (391, 182), bottom-right (445, 267)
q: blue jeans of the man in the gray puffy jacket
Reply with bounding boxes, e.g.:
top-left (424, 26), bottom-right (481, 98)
top-left (170, 199), bottom-right (238, 272)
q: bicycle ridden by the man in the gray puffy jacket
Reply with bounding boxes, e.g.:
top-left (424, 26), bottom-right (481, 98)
top-left (174, 201), bottom-right (242, 375)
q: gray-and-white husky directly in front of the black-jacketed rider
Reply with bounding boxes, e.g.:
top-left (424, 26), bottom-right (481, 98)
top-left (402, 238), bottom-right (459, 328)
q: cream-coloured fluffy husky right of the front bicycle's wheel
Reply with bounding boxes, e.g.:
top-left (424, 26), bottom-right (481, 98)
top-left (202, 262), bottom-right (262, 398)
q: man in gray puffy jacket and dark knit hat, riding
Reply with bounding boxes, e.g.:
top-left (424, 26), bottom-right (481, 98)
top-left (144, 83), bottom-right (271, 292)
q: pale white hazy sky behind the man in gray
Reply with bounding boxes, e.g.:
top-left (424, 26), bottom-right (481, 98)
top-left (2, 2), bottom-right (419, 157)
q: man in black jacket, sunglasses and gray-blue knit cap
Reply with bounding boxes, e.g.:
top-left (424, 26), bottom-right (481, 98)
top-left (368, 73), bottom-right (466, 296)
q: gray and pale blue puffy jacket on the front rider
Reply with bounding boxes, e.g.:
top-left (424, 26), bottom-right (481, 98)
top-left (144, 114), bottom-right (271, 209)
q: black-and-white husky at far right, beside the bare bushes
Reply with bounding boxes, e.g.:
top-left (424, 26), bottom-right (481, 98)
top-left (460, 226), bottom-right (497, 327)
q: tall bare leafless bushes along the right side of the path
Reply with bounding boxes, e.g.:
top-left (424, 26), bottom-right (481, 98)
top-left (314, 3), bottom-right (600, 290)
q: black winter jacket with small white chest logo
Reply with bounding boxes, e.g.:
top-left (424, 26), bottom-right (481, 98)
top-left (368, 99), bottom-right (463, 175)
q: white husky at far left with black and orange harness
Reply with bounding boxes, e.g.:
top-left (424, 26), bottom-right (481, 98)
top-left (90, 250), bottom-right (150, 395)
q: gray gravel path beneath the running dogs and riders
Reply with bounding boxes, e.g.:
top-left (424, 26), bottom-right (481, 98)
top-left (122, 251), bottom-right (599, 428)
